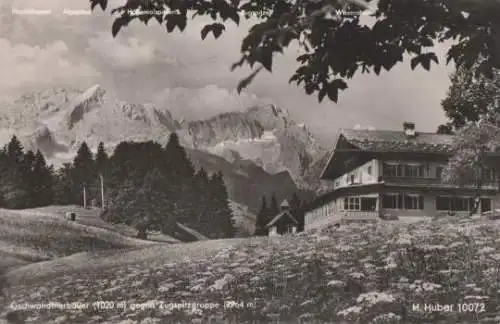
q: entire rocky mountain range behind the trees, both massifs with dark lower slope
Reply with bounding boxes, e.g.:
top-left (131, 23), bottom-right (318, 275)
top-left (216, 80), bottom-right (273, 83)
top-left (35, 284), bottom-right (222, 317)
top-left (0, 85), bottom-right (332, 213)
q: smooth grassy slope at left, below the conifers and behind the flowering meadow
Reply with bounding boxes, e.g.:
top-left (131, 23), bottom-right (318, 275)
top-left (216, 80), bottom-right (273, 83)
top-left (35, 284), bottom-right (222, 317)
top-left (0, 207), bottom-right (158, 270)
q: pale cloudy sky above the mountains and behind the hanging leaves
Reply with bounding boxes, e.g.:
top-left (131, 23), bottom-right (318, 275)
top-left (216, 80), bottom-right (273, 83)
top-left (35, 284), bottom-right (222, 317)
top-left (0, 0), bottom-right (453, 141)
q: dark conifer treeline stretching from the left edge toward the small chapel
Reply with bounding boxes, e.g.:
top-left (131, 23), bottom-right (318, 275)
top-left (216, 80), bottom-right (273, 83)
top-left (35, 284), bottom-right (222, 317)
top-left (0, 133), bottom-right (235, 238)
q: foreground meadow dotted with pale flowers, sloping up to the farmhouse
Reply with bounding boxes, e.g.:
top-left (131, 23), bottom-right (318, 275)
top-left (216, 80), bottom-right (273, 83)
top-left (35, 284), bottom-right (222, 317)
top-left (7, 219), bottom-right (500, 324)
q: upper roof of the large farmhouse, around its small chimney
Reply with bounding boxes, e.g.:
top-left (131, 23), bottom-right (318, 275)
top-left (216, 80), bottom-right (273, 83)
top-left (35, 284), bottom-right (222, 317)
top-left (340, 129), bottom-right (455, 154)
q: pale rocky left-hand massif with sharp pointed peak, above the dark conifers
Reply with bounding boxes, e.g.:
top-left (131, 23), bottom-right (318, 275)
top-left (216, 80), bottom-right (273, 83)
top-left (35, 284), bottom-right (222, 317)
top-left (0, 84), bottom-right (179, 161)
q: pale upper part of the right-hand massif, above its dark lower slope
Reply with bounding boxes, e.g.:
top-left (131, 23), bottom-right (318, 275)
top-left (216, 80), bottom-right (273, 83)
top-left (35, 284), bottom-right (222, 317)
top-left (181, 105), bottom-right (323, 182)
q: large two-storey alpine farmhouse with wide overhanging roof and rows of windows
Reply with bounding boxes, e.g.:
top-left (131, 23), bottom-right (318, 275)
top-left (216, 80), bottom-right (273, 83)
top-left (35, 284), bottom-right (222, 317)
top-left (304, 122), bottom-right (499, 230)
